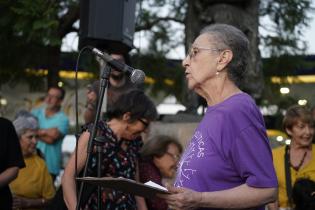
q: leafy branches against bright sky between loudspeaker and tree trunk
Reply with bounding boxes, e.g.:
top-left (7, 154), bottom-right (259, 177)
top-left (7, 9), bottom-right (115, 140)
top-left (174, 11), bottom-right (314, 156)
top-left (135, 0), bottom-right (187, 55)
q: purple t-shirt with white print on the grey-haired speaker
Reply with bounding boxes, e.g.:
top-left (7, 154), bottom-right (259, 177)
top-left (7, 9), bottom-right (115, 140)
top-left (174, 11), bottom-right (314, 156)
top-left (175, 93), bottom-right (278, 209)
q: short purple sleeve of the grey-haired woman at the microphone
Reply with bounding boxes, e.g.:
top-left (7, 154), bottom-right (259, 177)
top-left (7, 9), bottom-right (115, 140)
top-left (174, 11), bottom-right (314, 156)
top-left (231, 126), bottom-right (278, 187)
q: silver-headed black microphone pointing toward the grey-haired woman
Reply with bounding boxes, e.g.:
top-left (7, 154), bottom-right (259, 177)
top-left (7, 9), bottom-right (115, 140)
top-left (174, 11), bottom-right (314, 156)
top-left (90, 47), bottom-right (145, 84)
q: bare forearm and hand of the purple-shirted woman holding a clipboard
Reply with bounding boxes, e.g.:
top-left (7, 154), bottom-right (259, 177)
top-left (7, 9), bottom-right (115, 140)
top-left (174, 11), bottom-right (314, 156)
top-left (160, 184), bottom-right (277, 210)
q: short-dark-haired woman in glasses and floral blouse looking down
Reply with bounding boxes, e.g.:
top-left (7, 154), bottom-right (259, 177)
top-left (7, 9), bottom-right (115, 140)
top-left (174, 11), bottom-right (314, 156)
top-left (62, 90), bottom-right (157, 210)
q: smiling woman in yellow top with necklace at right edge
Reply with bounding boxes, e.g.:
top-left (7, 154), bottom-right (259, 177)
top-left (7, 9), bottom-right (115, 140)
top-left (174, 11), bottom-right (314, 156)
top-left (268, 105), bottom-right (315, 210)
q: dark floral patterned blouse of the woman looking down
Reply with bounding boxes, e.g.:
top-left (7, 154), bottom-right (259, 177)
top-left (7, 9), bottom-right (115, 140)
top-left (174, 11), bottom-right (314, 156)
top-left (83, 121), bottom-right (143, 210)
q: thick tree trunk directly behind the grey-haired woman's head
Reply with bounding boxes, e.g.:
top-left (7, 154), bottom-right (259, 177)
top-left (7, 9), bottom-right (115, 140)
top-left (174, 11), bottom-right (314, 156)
top-left (185, 0), bottom-right (264, 110)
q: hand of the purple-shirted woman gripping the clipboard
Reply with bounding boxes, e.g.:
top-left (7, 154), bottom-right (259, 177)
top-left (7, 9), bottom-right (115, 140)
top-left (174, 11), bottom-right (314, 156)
top-left (158, 187), bottom-right (202, 210)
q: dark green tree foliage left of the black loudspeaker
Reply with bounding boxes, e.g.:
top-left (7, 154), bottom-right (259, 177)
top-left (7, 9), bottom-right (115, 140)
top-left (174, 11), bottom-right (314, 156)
top-left (0, 0), bottom-right (79, 88)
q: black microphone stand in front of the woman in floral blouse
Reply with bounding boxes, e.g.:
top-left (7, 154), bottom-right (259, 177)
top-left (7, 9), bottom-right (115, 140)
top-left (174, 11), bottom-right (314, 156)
top-left (76, 64), bottom-right (111, 210)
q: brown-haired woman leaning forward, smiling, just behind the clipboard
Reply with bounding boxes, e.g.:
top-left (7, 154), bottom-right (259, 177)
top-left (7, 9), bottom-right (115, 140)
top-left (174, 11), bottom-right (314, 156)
top-left (139, 135), bottom-right (183, 210)
